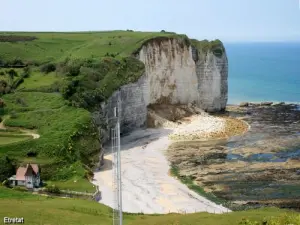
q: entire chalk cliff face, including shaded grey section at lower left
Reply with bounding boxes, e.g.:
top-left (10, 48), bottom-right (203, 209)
top-left (102, 38), bottom-right (228, 137)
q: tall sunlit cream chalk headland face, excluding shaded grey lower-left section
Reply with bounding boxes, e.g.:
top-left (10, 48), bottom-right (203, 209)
top-left (139, 39), bottom-right (228, 112)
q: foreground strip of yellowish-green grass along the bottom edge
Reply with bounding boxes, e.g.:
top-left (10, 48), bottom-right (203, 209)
top-left (0, 187), bottom-right (300, 225)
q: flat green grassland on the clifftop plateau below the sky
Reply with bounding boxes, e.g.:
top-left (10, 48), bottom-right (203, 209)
top-left (0, 31), bottom-right (223, 64)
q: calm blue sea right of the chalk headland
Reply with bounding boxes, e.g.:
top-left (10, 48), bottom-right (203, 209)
top-left (225, 43), bottom-right (300, 104)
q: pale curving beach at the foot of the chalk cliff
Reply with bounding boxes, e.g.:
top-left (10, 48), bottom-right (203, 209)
top-left (93, 115), bottom-right (230, 214)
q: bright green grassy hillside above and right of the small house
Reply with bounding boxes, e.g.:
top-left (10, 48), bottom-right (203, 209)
top-left (0, 92), bottom-right (100, 192)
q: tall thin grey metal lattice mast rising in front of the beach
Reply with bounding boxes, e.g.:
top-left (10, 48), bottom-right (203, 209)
top-left (111, 96), bottom-right (123, 225)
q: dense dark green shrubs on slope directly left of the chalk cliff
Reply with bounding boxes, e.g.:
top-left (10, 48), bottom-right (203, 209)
top-left (59, 57), bottom-right (144, 111)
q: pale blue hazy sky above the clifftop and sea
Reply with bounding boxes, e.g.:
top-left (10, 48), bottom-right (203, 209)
top-left (0, 0), bottom-right (300, 42)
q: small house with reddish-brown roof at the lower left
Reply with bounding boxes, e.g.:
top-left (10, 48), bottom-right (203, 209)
top-left (8, 164), bottom-right (41, 189)
